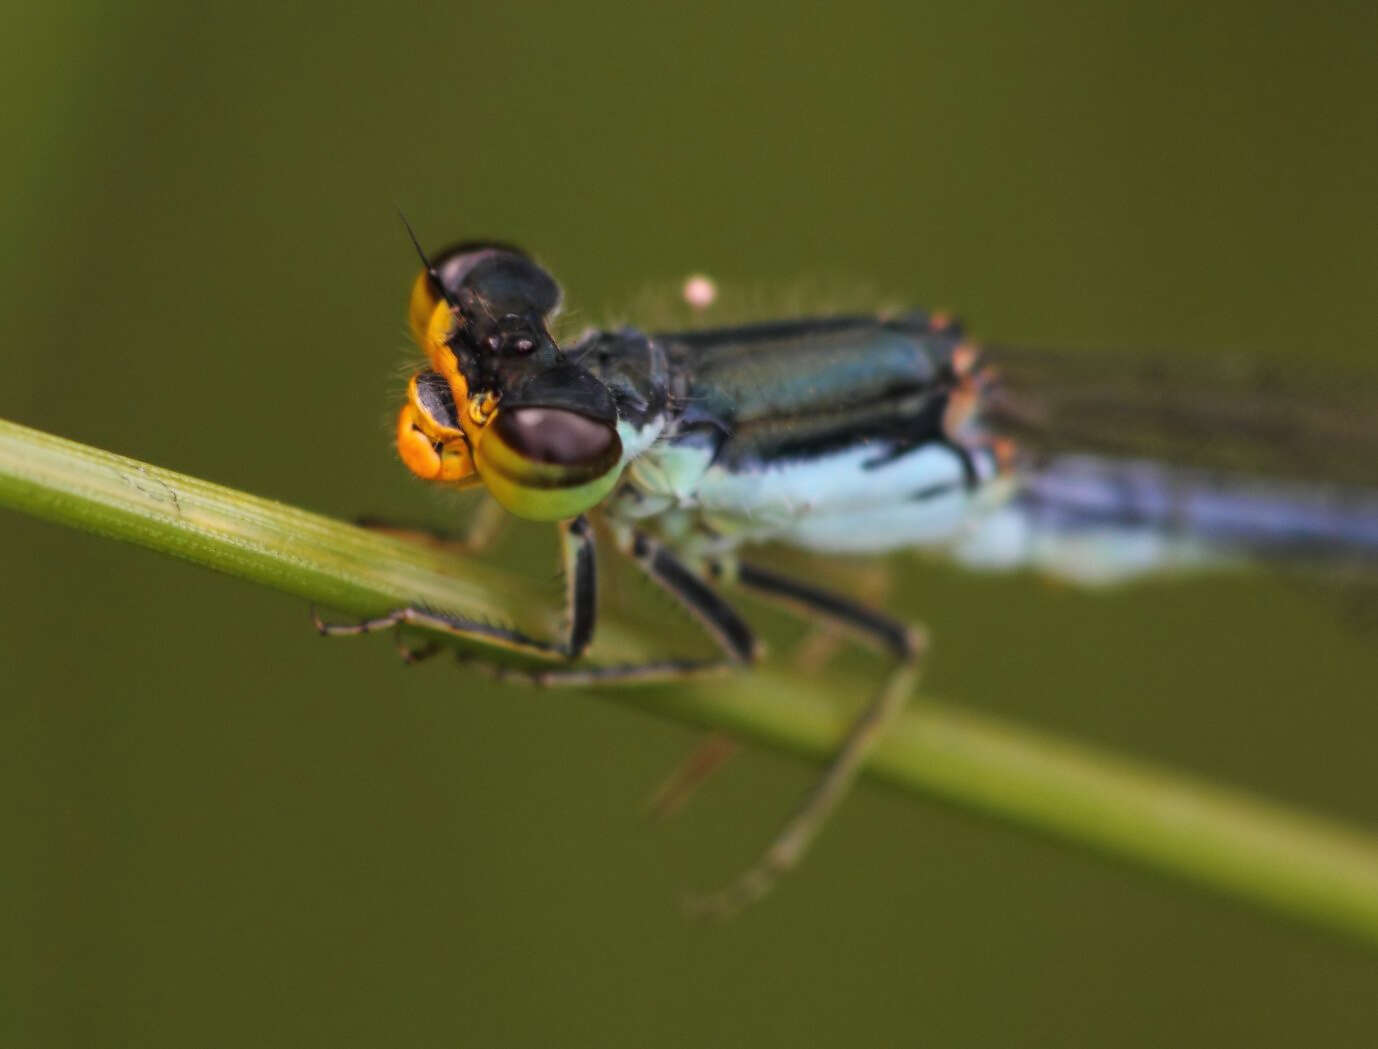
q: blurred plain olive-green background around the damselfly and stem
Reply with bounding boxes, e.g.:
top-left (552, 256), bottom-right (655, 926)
top-left (0, 0), bottom-right (1378, 1046)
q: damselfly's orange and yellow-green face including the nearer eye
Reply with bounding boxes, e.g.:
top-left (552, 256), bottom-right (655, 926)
top-left (398, 263), bottom-right (621, 521)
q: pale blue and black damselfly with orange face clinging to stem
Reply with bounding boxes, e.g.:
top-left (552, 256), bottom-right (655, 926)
top-left (320, 235), bottom-right (1378, 911)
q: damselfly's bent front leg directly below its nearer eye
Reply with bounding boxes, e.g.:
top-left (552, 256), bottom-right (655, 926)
top-left (313, 516), bottom-right (598, 662)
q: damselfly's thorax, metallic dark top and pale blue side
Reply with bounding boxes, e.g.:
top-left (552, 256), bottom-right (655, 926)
top-left (572, 314), bottom-right (1007, 553)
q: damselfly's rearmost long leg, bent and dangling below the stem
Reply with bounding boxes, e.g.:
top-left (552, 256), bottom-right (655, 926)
top-left (689, 565), bottom-right (926, 917)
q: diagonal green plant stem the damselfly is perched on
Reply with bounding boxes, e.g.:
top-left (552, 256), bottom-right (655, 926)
top-left (8, 420), bottom-right (1378, 946)
